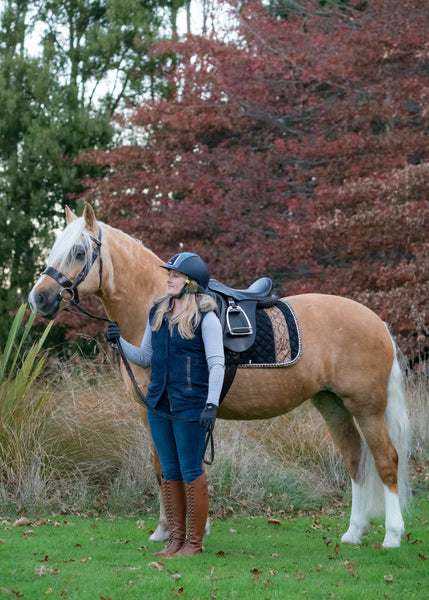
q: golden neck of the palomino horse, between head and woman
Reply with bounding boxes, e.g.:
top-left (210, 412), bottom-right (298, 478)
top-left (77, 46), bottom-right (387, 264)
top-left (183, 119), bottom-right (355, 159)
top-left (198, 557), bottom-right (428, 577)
top-left (99, 227), bottom-right (166, 345)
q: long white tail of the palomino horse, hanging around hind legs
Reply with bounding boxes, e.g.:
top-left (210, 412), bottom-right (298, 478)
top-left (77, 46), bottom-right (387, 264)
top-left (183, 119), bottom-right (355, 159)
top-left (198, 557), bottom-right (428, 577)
top-left (359, 333), bottom-right (411, 516)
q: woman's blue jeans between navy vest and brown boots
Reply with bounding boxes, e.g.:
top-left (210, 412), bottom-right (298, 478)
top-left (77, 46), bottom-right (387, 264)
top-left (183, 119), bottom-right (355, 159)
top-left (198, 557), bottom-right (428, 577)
top-left (148, 401), bottom-right (206, 483)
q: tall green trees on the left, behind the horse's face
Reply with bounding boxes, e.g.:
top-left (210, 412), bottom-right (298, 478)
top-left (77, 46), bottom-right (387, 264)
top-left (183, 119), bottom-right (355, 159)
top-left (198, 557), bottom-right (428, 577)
top-left (0, 0), bottom-right (177, 347)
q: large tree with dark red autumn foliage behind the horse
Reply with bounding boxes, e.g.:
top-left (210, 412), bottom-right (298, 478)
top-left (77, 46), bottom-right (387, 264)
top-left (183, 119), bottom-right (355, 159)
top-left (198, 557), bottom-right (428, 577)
top-left (79, 0), bottom-right (429, 356)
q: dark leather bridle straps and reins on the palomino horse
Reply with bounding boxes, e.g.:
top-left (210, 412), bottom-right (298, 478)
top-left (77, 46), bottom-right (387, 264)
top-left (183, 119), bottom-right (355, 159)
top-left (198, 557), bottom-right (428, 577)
top-left (43, 226), bottom-right (214, 465)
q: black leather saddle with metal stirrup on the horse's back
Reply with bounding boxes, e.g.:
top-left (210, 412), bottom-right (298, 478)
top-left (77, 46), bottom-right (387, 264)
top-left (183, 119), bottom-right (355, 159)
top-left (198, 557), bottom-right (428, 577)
top-left (208, 277), bottom-right (277, 353)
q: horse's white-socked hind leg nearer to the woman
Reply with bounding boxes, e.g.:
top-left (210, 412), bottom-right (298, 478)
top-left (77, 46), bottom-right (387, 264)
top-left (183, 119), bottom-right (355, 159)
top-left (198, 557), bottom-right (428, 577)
top-left (313, 391), bottom-right (369, 544)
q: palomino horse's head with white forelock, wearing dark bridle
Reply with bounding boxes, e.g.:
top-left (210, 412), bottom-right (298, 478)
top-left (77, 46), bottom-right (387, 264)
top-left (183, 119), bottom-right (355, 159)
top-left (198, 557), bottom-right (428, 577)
top-left (29, 204), bottom-right (102, 319)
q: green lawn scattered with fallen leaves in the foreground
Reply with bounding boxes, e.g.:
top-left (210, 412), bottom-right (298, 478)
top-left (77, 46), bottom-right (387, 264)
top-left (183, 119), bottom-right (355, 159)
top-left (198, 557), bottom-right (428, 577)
top-left (0, 489), bottom-right (429, 600)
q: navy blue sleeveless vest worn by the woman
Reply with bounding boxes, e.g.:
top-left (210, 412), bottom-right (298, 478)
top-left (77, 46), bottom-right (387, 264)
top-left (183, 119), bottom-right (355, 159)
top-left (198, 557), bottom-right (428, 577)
top-left (147, 306), bottom-right (209, 418)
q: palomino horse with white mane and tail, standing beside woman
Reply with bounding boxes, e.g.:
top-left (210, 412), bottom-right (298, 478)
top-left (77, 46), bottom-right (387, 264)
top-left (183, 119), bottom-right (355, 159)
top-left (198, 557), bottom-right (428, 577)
top-left (29, 205), bottom-right (409, 548)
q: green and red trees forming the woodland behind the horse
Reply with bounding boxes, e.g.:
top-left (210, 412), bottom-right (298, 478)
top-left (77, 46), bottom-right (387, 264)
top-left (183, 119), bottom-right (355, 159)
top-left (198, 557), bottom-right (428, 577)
top-left (0, 0), bottom-right (429, 357)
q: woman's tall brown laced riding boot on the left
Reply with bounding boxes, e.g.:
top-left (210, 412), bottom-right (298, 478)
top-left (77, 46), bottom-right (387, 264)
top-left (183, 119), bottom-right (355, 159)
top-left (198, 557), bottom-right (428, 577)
top-left (155, 478), bottom-right (186, 558)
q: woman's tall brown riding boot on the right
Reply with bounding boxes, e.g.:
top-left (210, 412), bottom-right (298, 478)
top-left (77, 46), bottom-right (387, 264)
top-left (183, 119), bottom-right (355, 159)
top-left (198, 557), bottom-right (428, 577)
top-left (175, 473), bottom-right (209, 556)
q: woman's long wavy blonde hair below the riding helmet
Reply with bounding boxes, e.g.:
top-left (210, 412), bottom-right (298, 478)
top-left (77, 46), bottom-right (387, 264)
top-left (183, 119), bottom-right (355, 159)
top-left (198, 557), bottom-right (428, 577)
top-left (150, 279), bottom-right (217, 340)
